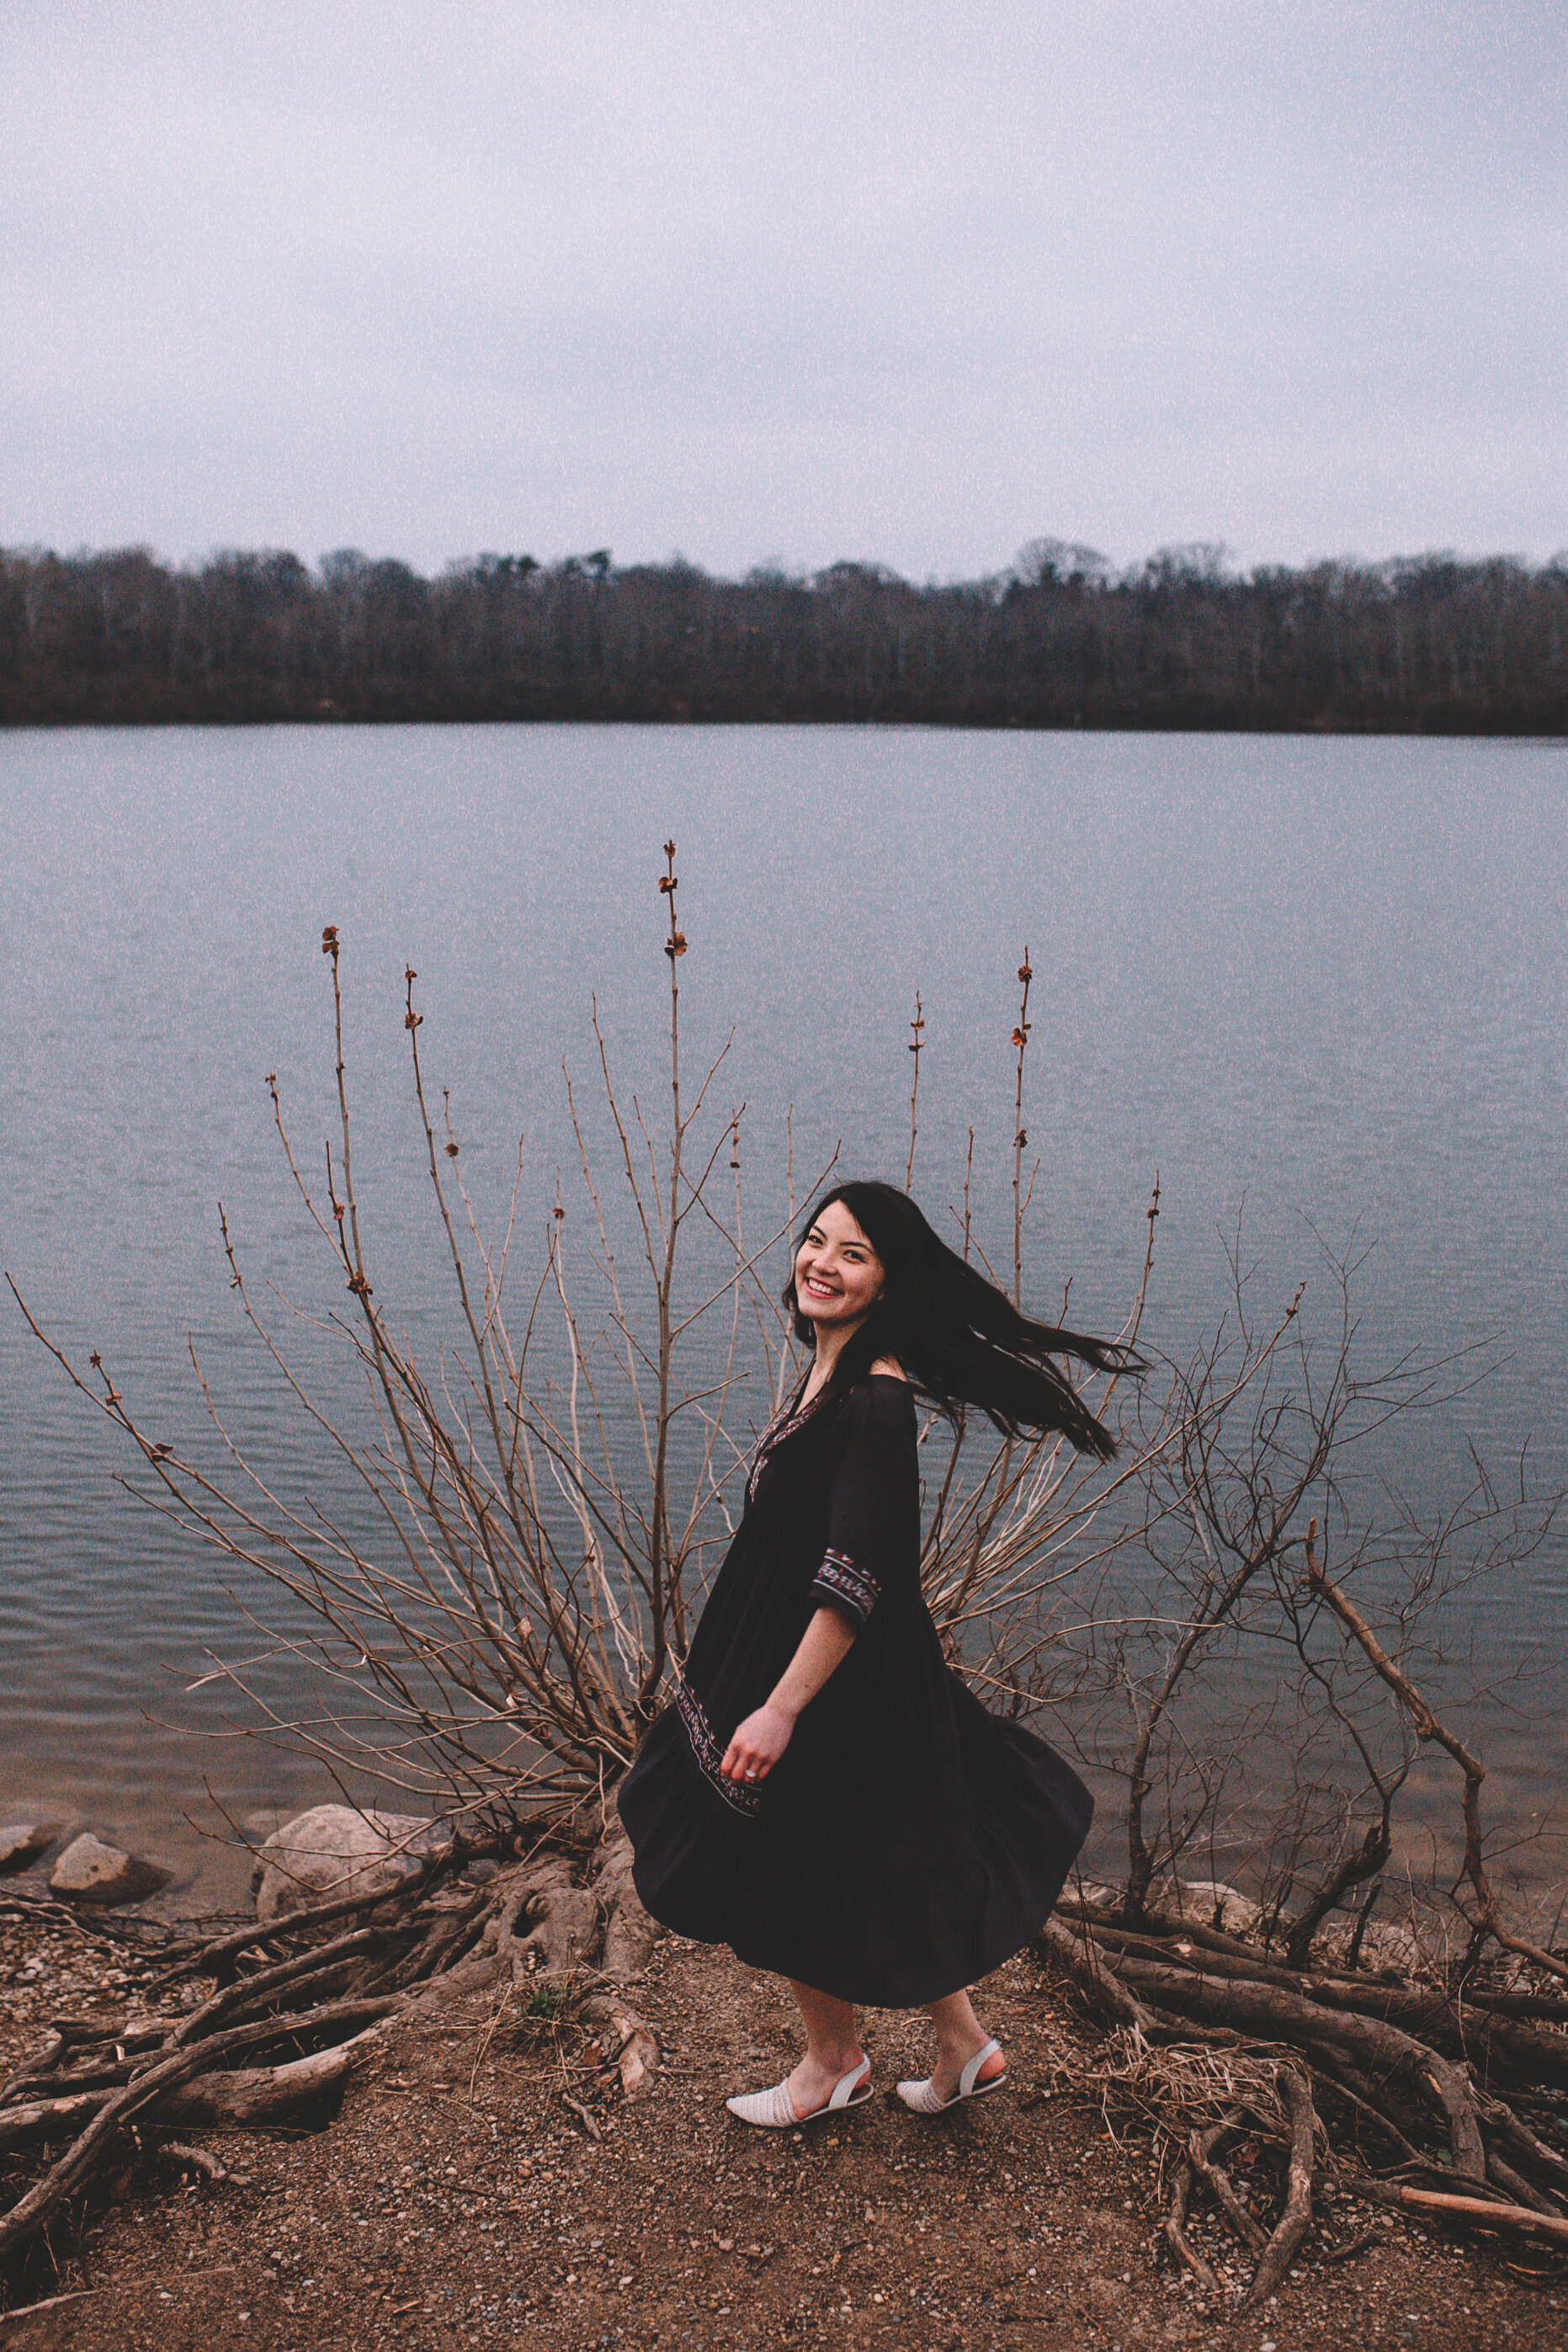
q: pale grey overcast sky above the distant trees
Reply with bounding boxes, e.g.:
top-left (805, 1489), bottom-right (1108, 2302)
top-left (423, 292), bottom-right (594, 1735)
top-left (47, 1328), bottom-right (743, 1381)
top-left (0, 0), bottom-right (1568, 578)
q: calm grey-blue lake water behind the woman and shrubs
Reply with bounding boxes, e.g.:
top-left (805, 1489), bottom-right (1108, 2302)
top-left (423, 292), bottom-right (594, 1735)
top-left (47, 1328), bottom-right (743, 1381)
top-left (0, 726), bottom-right (1568, 1901)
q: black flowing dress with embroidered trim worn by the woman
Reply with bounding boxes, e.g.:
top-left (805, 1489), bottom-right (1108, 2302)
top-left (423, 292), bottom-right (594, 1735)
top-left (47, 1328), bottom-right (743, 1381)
top-left (620, 1374), bottom-right (1093, 2009)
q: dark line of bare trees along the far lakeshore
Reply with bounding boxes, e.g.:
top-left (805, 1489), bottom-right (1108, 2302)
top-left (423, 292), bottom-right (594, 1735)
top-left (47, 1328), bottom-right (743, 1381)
top-left (0, 539), bottom-right (1568, 734)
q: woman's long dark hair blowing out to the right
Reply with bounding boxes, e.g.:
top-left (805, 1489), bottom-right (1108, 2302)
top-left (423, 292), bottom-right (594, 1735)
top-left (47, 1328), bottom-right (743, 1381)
top-left (783, 1183), bottom-right (1142, 1461)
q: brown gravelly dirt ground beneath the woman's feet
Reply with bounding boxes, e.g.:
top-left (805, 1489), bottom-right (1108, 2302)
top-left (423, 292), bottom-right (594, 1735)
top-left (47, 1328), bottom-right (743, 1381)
top-left (0, 1935), bottom-right (1568, 2352)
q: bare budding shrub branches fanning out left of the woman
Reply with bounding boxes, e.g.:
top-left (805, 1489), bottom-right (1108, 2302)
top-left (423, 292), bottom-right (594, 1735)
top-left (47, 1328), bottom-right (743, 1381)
top-left (12, 842), bottom-right (818, 1818)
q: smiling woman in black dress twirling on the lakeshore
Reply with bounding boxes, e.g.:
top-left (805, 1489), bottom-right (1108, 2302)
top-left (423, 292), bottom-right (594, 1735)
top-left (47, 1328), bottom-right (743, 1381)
top-left (620, 1183), bottom-right (1129, 2129)
